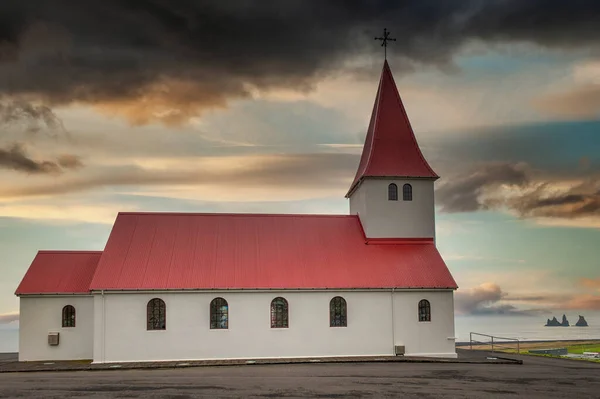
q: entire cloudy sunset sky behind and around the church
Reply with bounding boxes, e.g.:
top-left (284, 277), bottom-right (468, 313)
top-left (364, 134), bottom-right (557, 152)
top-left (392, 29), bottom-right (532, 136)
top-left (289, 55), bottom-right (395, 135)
top-left (0, 0), bottom-right (600, 323)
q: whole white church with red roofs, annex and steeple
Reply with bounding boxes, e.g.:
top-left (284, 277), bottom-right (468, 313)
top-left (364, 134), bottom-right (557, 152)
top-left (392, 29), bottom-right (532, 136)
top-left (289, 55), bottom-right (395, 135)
top-left (15, 61), bottom-right (457, 363)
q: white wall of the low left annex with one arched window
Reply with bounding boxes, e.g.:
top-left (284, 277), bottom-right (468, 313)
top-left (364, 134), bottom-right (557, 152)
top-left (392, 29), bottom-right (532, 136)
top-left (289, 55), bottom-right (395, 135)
top-left (19, 295), bottom-right (94, 361)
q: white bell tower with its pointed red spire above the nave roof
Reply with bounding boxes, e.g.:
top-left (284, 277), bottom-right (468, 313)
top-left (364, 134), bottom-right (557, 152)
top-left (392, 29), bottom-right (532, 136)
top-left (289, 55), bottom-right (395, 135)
top-left (346, 60), bottom-right (439, 239)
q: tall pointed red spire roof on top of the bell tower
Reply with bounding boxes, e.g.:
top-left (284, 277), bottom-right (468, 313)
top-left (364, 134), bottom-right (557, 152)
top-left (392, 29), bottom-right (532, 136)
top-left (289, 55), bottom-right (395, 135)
top-left (346, 61), bottom-right (439, 197)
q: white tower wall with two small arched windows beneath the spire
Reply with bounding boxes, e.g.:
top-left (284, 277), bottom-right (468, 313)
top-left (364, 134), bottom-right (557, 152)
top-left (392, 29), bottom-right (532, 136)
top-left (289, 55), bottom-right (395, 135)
top-left (350, 178), bottom-right (435, 238)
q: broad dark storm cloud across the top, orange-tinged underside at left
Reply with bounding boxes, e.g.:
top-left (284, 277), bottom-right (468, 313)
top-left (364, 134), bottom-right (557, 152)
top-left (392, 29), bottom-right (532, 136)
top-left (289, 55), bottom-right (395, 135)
top-left (0, 0), bottom-right (600, 123)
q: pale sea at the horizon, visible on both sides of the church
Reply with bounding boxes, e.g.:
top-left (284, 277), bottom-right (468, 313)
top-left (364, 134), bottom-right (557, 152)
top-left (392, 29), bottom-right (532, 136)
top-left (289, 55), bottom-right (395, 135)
top-left (0, 312), bottom-right (600, 353)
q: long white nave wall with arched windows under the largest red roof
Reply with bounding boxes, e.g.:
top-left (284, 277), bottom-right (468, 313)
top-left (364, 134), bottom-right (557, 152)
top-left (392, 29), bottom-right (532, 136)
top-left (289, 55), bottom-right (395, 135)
top-left (94, 291), bottom-right (454, 362)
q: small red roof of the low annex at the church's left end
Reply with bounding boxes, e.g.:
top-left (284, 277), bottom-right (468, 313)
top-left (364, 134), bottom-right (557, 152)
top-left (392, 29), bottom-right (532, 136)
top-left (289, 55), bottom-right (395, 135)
top-left (15, 251), bottom-right (102, 295)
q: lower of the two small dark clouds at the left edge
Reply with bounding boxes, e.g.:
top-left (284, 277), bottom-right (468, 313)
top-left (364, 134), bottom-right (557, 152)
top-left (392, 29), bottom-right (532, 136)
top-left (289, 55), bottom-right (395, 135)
top-left (0, 143), bottom-right (83, 174)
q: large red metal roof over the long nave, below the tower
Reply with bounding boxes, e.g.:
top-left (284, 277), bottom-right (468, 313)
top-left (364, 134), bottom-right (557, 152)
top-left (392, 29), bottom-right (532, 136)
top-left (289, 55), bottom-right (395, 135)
top-left (90, 213), bottom-right (456, 290)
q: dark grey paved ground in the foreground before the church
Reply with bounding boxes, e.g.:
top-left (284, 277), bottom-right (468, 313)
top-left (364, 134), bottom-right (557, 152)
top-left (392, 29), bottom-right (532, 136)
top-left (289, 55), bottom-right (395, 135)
top-left (0, 357), bottom-right (600, 399)
